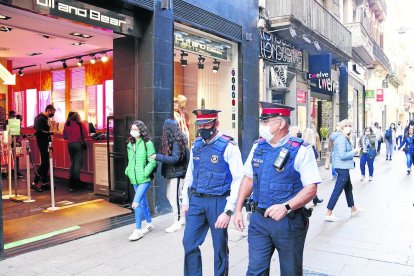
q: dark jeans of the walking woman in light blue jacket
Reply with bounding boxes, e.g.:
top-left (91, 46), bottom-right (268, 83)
top-left (328, 168), bottom-right (354, 211)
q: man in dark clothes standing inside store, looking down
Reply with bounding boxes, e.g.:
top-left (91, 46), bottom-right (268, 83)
top-left (31, 104), bottom-right (56, 192)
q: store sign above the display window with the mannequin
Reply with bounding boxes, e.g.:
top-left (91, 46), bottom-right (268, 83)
top-left (174, 30), bottom-right (232, 61)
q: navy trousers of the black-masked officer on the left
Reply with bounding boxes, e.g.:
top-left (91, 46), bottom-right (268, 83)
top-left (183, 195), bottom-right (229, 276)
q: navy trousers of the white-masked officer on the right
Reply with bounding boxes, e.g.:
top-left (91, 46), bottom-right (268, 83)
top-left (247, 212), bottom-right (309, 276)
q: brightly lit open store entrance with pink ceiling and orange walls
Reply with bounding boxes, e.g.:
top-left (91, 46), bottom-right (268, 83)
top-left (0, 5), bottom-right (131, 252)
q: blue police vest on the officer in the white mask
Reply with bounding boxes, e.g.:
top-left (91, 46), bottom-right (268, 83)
top-left (252, 137), bottom-right (303, 209)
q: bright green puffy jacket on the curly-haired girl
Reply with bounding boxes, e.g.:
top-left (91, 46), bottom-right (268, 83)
top-left (125, 138), bottom-right (157, 184)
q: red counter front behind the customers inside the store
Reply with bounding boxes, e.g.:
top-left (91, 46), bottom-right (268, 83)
top-left (29, 136), bottom-right (106, 183)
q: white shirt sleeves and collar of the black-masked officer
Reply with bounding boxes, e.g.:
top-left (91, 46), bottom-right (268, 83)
top-left (182, 132), bottom-right (243, 211)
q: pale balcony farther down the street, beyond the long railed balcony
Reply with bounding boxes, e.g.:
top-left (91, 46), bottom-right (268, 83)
top-left (345, 22), bottom-right (375, 64)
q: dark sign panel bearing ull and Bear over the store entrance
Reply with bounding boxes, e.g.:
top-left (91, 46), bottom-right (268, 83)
top-left (32, 0), bottom-right (134, 34)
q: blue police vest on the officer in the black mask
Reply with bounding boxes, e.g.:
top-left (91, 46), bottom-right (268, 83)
top-left (192, 136), bottom-right (233, 195)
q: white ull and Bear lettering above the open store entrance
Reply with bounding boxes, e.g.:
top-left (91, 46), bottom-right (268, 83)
top-left (36, 0), bottom-right (126, 27)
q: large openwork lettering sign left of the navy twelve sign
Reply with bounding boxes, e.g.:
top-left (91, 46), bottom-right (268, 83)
top-left (260, 31), bottom-right (303, 70)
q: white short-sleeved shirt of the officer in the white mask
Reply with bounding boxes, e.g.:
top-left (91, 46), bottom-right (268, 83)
top-left (243, 133), bottom-right (322, 187)
